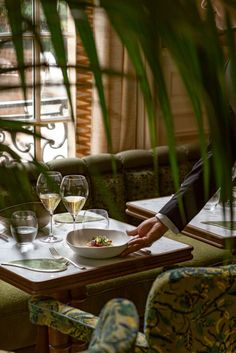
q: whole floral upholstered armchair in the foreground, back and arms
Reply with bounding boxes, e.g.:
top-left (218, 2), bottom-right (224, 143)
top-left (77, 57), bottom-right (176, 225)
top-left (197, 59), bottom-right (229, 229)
top-left (30, 265), bottom-right (236, 353)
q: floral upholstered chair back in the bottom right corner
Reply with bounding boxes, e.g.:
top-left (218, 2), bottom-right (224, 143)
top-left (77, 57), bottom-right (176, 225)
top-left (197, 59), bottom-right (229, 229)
top-left (145, 265), bottom-right (236, 353)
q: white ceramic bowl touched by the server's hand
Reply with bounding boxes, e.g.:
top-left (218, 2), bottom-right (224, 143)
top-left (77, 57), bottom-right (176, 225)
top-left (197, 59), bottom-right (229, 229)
top-left (66, 228), bottom-right (129, 259)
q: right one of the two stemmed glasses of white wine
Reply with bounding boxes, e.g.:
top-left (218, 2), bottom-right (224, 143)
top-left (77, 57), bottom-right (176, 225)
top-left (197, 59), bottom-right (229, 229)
top-left (60, 175), bottom-right (89, 230)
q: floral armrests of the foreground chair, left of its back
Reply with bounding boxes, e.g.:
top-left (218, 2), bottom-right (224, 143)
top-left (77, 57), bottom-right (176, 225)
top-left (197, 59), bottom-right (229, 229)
top-left (29, 298), bottom-right (139, 353)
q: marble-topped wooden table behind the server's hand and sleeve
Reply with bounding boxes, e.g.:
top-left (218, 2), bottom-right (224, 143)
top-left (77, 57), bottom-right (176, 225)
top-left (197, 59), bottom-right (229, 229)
top-left (126, 196), bottom-right (236, 249)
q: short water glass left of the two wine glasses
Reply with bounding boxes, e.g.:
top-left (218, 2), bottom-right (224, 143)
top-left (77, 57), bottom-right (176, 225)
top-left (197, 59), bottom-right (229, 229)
top-left (10, 210), bottom-right (38, 246)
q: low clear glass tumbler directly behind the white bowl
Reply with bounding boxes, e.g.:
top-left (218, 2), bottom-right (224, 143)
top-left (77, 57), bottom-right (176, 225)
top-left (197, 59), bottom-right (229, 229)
top-left (82, 208), bottom-right (109, 229)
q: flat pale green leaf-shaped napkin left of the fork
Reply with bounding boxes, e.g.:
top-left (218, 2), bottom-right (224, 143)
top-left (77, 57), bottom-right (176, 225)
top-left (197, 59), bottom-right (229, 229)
top-left (1, 259), bottom-right (67, 272)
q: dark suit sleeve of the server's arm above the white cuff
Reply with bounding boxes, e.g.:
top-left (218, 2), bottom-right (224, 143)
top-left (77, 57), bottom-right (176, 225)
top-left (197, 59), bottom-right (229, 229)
top-left (159, 150), bottom-right (216, 231)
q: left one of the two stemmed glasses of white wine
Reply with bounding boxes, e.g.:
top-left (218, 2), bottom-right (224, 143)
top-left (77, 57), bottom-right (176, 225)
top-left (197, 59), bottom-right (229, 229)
top-left (36, 171), bottom-right (62, 243)
